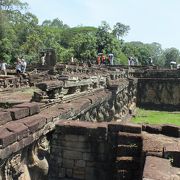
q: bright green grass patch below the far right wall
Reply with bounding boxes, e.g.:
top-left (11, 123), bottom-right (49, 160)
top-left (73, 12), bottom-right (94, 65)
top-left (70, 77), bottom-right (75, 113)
top-left (132, 109), bottom-right (180, 126)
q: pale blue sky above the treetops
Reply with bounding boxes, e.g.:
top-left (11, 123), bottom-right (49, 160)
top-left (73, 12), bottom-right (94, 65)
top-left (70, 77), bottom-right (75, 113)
top-left (23, 0), bottom-right (180, 50)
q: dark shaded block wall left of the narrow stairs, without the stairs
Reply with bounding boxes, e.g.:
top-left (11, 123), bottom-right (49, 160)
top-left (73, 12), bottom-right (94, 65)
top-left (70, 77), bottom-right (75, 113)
top-left (49, 122), bottom-right (111, 180)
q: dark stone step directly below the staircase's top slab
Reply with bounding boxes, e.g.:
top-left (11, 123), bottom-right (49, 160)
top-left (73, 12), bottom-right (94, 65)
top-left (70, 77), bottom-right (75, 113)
top-left (117, 132), bottom-right (142, 147)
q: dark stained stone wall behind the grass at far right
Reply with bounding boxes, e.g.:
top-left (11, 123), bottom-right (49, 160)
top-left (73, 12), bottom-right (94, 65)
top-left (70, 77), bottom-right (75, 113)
top-left (137, 78), bottom-right (180, 110)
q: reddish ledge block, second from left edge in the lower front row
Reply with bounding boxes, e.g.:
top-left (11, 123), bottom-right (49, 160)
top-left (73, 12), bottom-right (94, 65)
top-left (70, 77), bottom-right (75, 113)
top-left (6, 121), bottom-right (29, 140)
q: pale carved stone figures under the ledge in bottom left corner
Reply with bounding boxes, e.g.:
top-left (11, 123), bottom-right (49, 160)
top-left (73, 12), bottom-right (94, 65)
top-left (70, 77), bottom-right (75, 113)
top-left (0, 136), bottom-right (49, 180)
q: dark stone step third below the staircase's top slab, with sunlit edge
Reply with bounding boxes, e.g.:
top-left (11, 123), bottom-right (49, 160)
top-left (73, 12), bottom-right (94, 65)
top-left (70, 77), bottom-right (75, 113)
top-left (116, 156), bottom-right (140, 170)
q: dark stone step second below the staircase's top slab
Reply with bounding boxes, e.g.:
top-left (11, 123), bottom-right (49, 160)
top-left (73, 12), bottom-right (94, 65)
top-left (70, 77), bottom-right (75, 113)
top-left (117, 144), bottom-right (142, 157)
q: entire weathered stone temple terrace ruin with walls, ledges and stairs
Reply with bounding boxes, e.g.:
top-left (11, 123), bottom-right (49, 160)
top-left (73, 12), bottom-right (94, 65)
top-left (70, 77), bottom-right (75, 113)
top-left (0, 61), bottom-right (180, 180)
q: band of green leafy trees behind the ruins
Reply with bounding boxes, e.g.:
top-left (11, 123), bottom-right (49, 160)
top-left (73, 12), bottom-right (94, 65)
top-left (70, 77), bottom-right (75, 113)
top-left (0, 0), bottom-right (180, 67)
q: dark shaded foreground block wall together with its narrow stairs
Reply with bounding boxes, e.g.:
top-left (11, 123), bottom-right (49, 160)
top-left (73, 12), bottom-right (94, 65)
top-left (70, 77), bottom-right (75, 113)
top-left (49, 120), bottom-right (142, 180)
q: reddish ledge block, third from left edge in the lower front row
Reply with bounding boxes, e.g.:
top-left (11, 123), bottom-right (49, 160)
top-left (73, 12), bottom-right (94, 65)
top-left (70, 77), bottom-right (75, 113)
top-left (18, 115), bottom-right (46, 133)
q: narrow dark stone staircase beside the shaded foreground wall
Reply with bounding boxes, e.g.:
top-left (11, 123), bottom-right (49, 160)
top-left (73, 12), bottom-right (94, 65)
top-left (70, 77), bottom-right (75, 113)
top-left (110, 125), bottom-right (142, 180)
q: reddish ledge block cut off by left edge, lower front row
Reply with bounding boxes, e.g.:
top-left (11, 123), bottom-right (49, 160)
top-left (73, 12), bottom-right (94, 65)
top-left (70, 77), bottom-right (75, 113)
top-left (0, 127), bottom-right (17, 148)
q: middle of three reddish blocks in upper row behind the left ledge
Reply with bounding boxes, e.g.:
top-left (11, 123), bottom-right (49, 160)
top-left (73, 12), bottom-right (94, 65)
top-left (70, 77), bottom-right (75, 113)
top-left (7, 108), bottom-right (29, 120)
